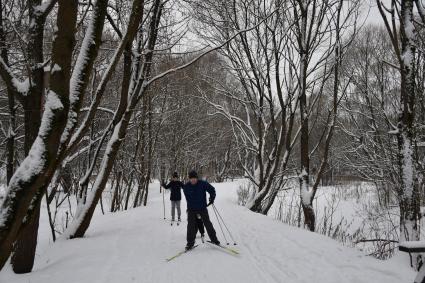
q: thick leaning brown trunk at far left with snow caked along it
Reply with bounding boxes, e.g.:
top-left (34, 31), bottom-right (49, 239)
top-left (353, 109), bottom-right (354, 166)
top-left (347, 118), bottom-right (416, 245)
top-left (0, 0), bottom-right (78, 270)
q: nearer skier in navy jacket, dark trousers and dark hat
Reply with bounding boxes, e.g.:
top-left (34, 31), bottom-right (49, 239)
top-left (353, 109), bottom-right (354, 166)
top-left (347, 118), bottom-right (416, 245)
top-left (183, 171), bottom-right (220, 250)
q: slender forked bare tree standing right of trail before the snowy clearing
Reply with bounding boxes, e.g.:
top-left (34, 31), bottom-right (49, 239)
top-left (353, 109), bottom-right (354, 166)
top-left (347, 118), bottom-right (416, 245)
top-left (287, 0), bottom-right (359, 231)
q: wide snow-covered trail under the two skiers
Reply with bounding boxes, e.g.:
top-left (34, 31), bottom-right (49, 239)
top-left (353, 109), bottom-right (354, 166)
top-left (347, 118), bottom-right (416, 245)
top-left (0, 182), bottom-right (414, 283)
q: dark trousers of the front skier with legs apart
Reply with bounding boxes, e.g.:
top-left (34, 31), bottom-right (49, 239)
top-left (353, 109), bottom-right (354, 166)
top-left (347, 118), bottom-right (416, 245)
top-left (186, 208), bottom-right (218, 245)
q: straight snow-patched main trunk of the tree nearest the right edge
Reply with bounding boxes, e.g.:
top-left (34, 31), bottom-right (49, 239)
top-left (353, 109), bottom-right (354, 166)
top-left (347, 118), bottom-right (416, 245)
top-left (397, 0), bottom-right (421, 244)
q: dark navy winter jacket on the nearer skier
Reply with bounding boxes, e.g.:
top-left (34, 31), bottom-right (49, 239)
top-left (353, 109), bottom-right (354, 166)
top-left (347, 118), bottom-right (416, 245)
top-left (183, 180), bottom-right (215, 210)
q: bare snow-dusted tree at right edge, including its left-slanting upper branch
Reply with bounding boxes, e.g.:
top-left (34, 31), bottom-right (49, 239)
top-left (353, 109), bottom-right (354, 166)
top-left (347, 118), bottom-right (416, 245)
top-left (376, 0), bottom-right (425, 253)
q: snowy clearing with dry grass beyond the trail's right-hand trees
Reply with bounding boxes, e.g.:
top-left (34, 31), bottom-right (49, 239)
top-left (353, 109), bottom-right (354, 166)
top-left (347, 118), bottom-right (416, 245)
top-left (269, 182), bottom-right (402, 259)
